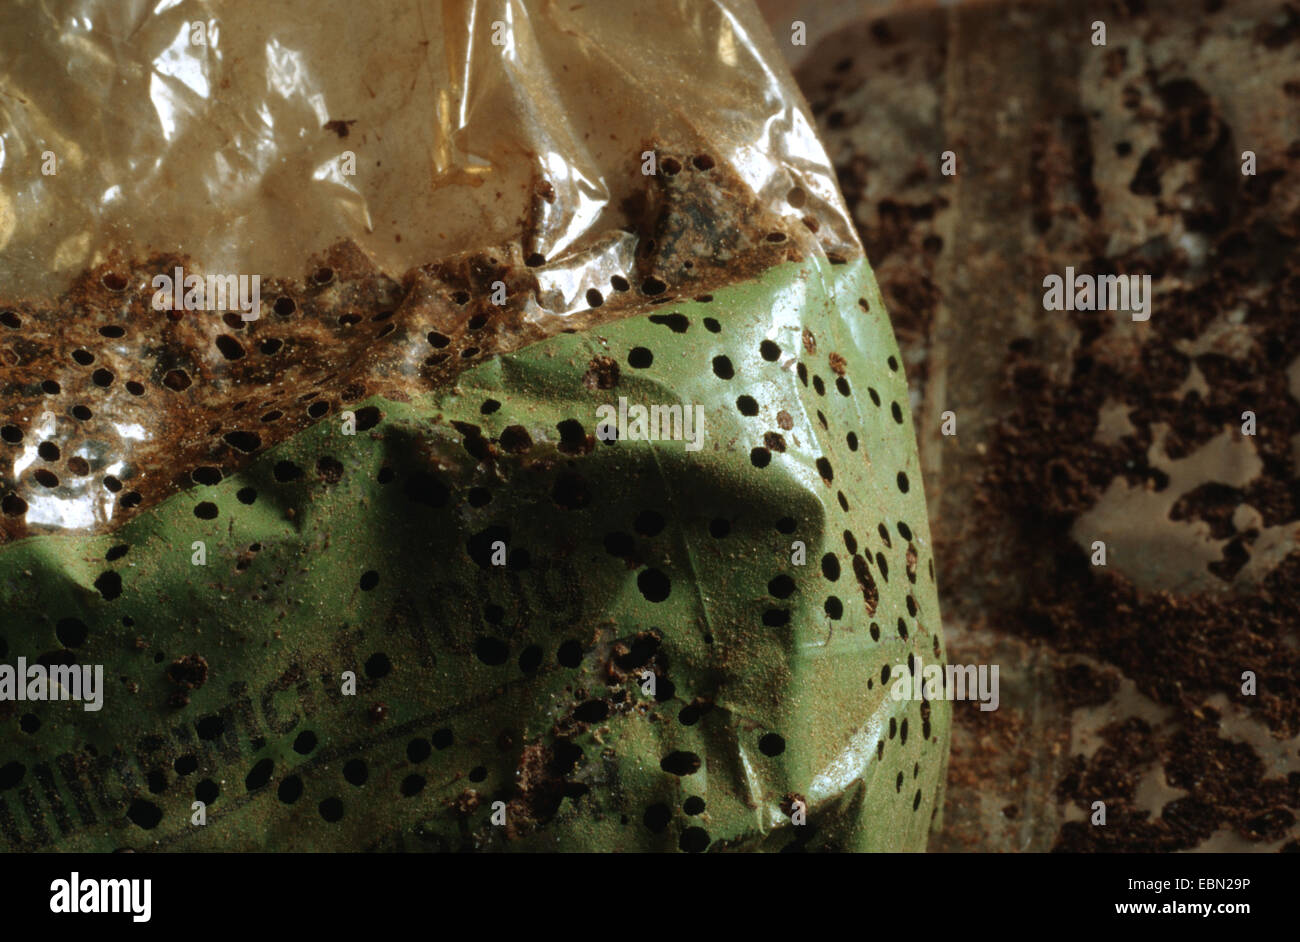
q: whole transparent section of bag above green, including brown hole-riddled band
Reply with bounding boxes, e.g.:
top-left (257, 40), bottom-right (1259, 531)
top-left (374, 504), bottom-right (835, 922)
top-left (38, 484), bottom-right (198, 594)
top-left (0, 0), bottom-right (861, 541)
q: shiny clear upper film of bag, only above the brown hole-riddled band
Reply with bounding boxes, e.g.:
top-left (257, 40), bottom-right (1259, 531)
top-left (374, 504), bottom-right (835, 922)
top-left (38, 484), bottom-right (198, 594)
top-left (0, 0), bottom-right (857, 301)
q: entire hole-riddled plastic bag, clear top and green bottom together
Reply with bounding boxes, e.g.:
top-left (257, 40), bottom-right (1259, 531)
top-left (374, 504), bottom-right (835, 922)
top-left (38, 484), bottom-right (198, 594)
top-left (0, 3), bottom-right (950, 851)
